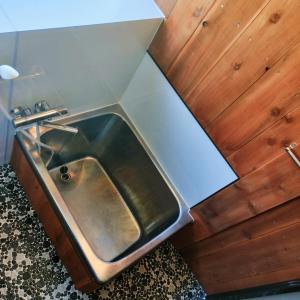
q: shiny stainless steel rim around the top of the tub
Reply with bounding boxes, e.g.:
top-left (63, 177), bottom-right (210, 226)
top-left (17, 104), bottom-right (193, 283)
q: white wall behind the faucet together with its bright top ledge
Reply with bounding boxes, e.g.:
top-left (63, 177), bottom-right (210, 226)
top-left (0, 0), bottom-right (163, 163)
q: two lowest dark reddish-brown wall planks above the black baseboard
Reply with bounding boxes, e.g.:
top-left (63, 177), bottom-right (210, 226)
top-left (182, 198), bottom-right (300, 294)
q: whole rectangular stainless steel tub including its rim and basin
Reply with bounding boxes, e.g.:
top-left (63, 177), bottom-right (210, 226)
top-left (18, 105), bottom-right (192, 282)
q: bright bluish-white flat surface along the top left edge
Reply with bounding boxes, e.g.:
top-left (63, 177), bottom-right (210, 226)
top-left (0, 0), bottom-right (164, 33)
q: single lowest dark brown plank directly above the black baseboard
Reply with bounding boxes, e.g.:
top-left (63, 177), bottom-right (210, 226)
top-left (191, 223), bottom-right (300, 294)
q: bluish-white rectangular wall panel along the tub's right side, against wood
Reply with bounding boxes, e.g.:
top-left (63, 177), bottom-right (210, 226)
top-left (120, 54), bottom-right (237, 207)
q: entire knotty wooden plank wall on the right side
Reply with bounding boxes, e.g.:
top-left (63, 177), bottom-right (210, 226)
top-left (149, 0), bottom-right (300, 294)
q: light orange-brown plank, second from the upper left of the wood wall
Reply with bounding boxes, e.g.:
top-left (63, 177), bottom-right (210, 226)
top-left (167, 0), bottom-right (269, 98)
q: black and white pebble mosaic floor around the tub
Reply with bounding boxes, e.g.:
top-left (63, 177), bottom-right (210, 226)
top-left (0, 165), bottom-right (205, 300)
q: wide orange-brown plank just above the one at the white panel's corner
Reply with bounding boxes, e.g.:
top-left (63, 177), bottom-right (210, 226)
top-left (208, 39), bottom-right (300, 156)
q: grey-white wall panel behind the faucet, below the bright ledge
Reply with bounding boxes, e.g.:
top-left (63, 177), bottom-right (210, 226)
top-left (12, 20), bottom-right (160, 110)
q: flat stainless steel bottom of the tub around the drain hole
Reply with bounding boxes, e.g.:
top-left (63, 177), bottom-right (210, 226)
top-left (49, 156), bottom-right (141, 261)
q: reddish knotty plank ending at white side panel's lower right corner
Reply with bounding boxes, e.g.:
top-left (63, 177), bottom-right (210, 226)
top-left (228, 107), bottom-right (300, 177)
